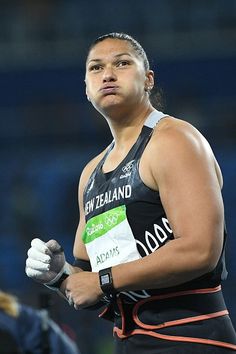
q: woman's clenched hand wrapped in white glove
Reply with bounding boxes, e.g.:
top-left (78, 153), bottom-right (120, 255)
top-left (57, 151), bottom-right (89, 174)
top-left (25, 238), bottom-right (66, 284)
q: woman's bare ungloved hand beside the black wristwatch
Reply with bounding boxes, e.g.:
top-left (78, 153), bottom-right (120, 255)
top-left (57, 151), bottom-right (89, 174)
top-left (63, 271), bottom-right (104, 310)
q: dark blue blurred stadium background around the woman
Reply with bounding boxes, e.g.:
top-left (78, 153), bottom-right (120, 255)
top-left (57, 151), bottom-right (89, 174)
top-left (0, 0), bottom-right (236, 354)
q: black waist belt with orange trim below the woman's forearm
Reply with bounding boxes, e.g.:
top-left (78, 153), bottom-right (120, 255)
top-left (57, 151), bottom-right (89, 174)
top-left (100, 286), bottom-right (236, 350)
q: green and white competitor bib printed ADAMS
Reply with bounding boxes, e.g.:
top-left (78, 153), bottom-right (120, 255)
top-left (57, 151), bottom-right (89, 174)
top-left (82, 205), bottom-right (141, 272)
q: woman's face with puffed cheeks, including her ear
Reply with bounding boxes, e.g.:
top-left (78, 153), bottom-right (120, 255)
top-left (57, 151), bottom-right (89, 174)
top-left (85, 38), bottom-right (153, 115)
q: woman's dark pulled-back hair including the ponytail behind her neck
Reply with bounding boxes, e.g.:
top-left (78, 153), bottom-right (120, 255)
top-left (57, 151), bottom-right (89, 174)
top-left (88, 32), bottom-right (164, 109)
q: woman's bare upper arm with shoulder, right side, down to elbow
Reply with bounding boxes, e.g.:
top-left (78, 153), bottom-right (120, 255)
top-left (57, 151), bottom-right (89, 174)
top-left (150, 123), bottom-right (224, 267)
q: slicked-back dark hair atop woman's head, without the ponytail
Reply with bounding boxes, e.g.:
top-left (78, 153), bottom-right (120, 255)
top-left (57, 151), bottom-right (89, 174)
top-left (88, 32), bottom-right (150, 70)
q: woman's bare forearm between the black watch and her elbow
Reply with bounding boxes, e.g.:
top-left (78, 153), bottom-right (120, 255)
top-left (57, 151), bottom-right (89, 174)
top-left (112, 238), bottom-right (215, 291)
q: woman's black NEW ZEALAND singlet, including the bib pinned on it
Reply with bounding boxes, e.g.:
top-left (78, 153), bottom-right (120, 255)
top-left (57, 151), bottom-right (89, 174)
top-left (82, 110), bottom-right (227, 302)
